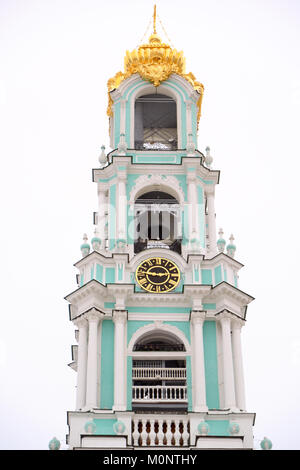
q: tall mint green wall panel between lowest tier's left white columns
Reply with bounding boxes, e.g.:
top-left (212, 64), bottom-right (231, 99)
top-left (100, 320), bottom-right (114, 410)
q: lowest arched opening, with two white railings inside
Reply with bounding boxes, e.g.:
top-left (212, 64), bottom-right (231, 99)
top-left (132, 330), bottom-right (187, 410)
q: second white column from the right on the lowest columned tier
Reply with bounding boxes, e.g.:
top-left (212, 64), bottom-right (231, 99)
top-left (220, 315), bottom-right (236, 410)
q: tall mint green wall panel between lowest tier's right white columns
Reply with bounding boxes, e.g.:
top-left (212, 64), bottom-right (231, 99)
top-left (203, 321), bottom-right (220, 409)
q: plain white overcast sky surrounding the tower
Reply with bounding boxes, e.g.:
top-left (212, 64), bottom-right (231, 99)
top-left (0, 0), bottom-right (300, 449)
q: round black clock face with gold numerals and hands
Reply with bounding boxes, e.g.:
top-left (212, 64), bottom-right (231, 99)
top-left (135, 257), bottom-right (180, 294)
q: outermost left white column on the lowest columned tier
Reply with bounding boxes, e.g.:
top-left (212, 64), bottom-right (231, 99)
top-left (74, 318), bottom-right (88, 410)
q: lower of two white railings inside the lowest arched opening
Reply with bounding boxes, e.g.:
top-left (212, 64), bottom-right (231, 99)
top-left (132, 385), bottom-right (187, 403)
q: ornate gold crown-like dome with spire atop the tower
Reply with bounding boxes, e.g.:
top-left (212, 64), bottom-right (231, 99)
top-left (107, 5), bottom-right (204, 123)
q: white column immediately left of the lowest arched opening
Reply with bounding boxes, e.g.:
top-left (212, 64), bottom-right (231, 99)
top-left (113, 310), bottom-right (127, 411)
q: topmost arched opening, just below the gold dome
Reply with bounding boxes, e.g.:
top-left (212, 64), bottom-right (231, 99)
top-left (134, 93), bottom-right (178, 150)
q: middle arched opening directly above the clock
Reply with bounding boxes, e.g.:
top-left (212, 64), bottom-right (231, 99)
top-left (134, 191), bottom-right (181, 254)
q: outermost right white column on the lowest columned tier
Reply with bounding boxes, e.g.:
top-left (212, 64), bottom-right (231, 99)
top-left (232, 320), bottom-right (246, 411)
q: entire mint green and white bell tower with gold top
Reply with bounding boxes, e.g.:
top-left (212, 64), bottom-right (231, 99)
top-left (66, 8), bottom-right (255, 449)
